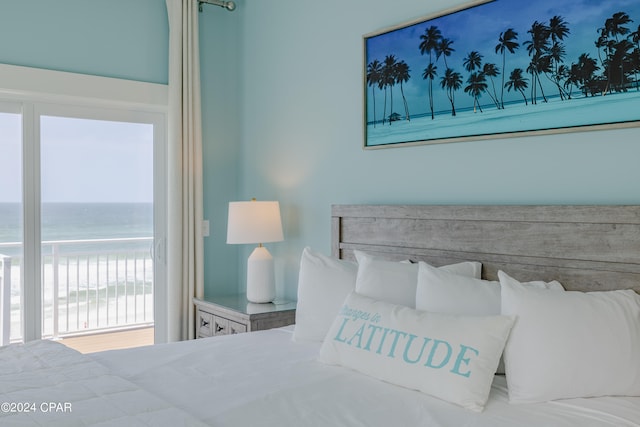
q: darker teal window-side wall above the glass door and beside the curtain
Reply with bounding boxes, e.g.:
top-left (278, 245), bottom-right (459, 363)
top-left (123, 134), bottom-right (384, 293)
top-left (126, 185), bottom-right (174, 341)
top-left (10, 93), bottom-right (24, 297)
top-left (0, 0), bottom-right (242, 295)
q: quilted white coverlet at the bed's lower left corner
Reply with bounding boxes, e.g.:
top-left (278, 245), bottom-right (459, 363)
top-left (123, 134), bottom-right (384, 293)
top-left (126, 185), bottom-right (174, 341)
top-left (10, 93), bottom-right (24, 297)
top-left (0, 341), bottom-right (205, 427)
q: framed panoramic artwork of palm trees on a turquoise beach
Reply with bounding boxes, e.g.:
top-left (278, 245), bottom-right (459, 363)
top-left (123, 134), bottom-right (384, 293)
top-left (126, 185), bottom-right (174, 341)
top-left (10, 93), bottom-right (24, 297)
top-left (363, 0), bottom-right (640, 148)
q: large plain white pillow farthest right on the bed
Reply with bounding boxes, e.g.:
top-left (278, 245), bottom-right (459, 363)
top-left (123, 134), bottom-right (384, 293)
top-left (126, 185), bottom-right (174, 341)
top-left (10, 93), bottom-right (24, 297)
top-left (500, 276), bottom-right (640, 403)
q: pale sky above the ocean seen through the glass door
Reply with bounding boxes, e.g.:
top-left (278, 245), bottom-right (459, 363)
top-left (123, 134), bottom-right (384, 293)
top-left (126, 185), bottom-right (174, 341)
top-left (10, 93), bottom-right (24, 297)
top-left (0, 113), bottom-right (153, 203)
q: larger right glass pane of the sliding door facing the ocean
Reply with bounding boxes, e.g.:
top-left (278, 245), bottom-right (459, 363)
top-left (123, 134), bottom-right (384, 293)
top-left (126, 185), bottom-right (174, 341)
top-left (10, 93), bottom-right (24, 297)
top-left (39, 114), bottom-right (154, 338)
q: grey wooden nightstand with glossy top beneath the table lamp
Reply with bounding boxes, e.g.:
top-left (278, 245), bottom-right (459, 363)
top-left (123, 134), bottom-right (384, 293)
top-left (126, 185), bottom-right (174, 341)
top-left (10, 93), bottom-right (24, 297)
top-left (193, 294), bottom-right (296, 338)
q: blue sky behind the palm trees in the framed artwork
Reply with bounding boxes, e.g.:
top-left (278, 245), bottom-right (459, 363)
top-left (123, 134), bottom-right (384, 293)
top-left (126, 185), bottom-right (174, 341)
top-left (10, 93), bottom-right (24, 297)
top-left (365, 0), bottom-right (640, 118)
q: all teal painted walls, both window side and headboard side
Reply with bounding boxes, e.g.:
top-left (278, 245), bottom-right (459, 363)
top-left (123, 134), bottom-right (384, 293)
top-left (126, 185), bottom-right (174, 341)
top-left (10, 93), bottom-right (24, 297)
top-left (0, 0), bottom-right (640, 298)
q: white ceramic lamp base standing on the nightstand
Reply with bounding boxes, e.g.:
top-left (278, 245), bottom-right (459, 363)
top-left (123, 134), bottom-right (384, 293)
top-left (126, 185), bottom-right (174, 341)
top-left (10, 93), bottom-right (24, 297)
top-left (247, 246), bottom-right (276, 303)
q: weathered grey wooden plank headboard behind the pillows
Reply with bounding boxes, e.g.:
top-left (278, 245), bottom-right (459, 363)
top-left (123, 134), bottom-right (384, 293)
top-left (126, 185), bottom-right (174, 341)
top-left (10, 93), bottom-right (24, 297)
top-left (332, 205), bottom-right (640, 293)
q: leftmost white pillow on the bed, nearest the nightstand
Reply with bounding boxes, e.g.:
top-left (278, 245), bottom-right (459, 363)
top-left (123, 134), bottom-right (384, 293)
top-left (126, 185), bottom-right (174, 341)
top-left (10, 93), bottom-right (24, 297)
top-left (293, 248), bottom-right (358, 342)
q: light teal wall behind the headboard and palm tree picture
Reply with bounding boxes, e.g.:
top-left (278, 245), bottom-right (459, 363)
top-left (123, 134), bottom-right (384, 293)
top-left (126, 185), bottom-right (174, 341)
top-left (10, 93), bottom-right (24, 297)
top-left (239, 0), bottom-right (640, 298)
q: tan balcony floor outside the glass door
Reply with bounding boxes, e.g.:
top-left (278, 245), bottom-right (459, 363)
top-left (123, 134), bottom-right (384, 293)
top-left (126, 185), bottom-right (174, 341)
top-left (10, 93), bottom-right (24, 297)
top-left (60, 327), bottom-right (153, 353)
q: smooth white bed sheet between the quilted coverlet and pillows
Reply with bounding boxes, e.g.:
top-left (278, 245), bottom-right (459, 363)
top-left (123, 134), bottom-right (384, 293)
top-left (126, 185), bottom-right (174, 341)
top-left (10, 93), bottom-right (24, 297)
top-left (91, 328), bottom-right (640, 427)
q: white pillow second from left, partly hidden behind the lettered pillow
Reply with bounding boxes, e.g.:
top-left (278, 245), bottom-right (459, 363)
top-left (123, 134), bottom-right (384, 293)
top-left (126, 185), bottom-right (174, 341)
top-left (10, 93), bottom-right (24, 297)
top-left (353, 251), bottom-right (482, 308)
